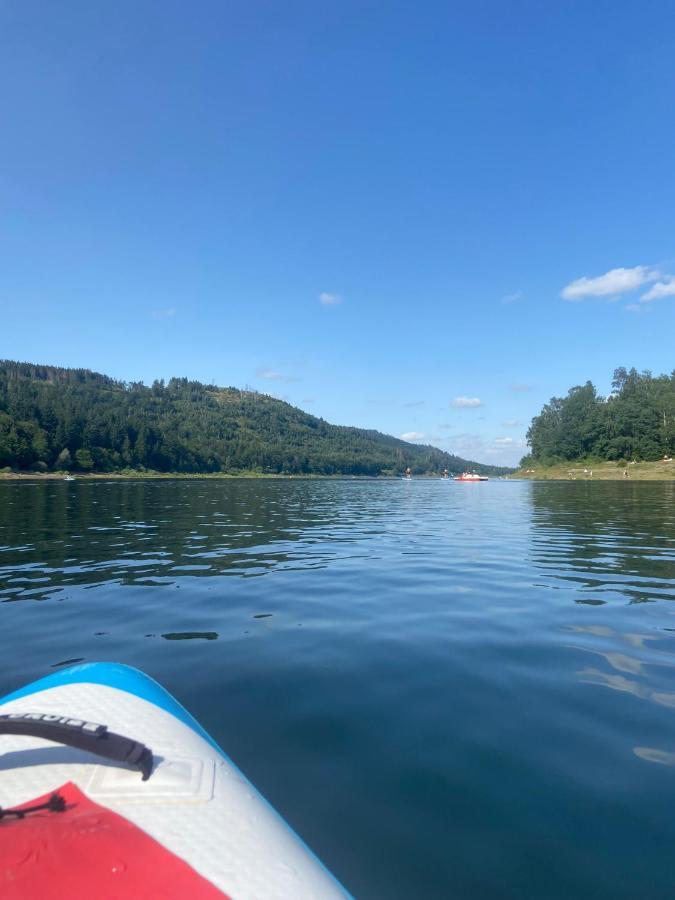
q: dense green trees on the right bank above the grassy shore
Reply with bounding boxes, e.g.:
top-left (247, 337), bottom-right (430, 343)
top-left (521, 368), bottom-right (675, 466)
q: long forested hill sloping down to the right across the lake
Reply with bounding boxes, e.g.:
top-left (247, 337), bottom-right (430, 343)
top-left (0, 360), bottom-right (511, 475)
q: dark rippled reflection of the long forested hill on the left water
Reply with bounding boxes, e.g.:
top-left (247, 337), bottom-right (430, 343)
top-left (0, 480), bottom-right (390, 601)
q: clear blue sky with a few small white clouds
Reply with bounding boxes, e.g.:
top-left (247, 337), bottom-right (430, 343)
top-left (0, 0), bottom-right (675, 464)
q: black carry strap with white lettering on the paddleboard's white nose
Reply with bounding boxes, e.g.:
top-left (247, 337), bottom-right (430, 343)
top-left (0, 713), bottom-right (152, 781)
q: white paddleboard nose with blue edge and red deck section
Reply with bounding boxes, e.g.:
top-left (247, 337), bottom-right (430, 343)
top-left (0, 663), bottom-right (349, 900)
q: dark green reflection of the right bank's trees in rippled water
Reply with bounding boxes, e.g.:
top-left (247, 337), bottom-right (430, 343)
top-left (531, 482), bottom-right (675, 605)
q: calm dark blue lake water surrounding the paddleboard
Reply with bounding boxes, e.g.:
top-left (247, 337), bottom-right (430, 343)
top-left (0, 479), bottom-right (675, 900)
